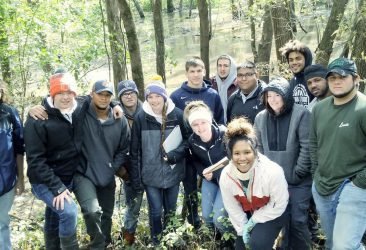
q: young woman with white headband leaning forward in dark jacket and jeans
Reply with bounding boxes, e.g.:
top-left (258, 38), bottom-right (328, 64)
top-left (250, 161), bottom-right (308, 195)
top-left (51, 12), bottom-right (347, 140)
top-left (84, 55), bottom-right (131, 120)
top-left (184, 101), bottom-right (230, 246)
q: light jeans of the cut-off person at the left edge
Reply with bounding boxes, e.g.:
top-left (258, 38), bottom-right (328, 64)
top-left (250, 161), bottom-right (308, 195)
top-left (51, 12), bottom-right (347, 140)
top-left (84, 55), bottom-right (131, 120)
top-left (0, 188), bottom-right (15, 250)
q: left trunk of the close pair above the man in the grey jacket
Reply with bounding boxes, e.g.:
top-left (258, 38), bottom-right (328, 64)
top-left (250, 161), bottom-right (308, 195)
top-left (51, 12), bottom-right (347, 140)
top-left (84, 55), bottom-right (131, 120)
top-left (105, 0), bottom-right (127, 89)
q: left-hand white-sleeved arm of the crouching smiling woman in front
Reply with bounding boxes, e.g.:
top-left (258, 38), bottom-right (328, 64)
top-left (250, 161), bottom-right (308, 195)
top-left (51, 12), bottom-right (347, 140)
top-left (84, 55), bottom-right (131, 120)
top-left (220, 172), bottom-right (248, 236)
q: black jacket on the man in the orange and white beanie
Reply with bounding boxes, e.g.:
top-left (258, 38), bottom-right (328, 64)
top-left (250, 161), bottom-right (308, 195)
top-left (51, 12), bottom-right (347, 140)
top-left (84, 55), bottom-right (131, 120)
top-left (24, 96), bottom-right (90, 196)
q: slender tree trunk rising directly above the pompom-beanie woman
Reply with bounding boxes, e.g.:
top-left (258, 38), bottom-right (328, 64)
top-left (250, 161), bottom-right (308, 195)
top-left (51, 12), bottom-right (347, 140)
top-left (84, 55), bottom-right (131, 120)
top-left (153, 0), bottom-right (166, 83)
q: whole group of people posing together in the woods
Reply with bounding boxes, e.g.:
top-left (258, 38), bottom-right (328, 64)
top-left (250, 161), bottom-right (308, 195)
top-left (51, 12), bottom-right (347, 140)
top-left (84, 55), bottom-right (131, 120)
top-left (0, 40), bottom-right (366, 250)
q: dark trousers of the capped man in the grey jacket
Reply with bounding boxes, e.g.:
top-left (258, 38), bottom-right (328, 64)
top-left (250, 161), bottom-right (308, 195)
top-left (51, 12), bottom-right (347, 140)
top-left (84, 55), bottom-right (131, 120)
top-left (74, 173), bottom-right (116, 249)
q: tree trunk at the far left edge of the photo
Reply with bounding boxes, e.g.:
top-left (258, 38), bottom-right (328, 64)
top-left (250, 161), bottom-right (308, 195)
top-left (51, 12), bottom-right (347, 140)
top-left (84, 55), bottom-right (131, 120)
top-left (0, 1), bottom-right (11, 84)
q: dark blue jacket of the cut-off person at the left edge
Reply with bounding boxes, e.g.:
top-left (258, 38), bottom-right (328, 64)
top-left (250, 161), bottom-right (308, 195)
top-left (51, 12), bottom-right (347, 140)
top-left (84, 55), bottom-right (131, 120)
top-left (0, 103), bottom-right (24, 196)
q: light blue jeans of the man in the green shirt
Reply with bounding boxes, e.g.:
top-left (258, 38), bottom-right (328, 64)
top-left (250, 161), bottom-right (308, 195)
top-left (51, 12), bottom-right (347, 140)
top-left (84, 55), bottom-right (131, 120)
top-left (312, 180), bottom-right (366, 250)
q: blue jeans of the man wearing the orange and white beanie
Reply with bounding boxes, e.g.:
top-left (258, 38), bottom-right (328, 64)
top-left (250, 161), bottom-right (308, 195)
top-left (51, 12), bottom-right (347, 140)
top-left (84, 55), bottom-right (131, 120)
top-left (32, 184), bottom-right (78, 237)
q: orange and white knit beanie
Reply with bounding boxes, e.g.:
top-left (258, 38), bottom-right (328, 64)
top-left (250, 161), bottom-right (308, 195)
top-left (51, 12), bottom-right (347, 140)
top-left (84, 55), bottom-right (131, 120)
top-left (50, 73), bottom-right (76, 98)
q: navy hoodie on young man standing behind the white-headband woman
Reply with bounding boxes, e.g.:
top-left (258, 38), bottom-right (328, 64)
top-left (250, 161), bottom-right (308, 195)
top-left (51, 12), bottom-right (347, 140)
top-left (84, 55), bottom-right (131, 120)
top-left (170, 81), bottom-right (224, 124)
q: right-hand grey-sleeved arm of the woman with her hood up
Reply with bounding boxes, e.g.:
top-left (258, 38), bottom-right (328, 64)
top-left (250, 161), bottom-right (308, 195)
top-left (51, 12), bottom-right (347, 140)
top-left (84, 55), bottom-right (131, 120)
top-left (295, 110), bottom-right (311, 178)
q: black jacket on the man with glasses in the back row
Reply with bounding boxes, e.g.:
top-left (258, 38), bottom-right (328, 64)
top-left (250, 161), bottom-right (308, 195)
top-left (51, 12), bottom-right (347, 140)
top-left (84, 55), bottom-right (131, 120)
top-left (226, 80), bottom-right (266, 124)
